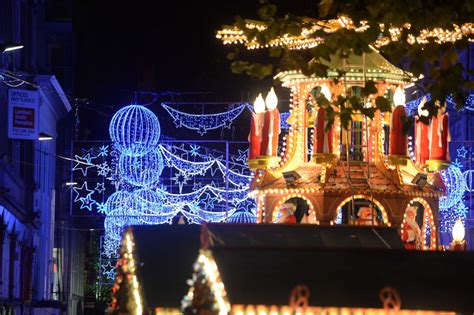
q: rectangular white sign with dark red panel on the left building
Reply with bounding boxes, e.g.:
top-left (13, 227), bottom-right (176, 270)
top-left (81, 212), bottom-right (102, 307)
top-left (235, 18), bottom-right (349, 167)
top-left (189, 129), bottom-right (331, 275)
top-left (8, 89), bottom-right (39, 140)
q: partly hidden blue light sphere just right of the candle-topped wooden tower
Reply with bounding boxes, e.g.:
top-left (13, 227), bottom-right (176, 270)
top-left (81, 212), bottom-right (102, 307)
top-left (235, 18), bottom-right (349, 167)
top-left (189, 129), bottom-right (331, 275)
top-left (439, 165), bottom-right (467, 209)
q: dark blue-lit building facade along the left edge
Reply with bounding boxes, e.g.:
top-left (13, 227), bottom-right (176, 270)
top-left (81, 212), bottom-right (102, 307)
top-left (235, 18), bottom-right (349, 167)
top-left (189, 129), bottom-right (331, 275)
top-left (0, 0), bottom-right (79, 314)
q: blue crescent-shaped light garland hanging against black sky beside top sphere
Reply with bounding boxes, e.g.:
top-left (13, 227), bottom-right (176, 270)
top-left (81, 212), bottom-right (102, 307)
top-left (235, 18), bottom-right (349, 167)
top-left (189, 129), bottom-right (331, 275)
top-left (161, 104), bottom-right (247, 136)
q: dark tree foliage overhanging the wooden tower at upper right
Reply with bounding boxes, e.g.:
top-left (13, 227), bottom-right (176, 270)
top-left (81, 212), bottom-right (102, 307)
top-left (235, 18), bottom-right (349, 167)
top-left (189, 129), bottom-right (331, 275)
top-left (223, 0), bottom-right (474, 125)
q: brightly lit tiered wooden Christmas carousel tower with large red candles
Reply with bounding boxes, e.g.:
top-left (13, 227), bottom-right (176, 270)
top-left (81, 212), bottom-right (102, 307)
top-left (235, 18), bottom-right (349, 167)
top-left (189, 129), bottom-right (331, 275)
top-left (249, 50), bottom-right (449, 250)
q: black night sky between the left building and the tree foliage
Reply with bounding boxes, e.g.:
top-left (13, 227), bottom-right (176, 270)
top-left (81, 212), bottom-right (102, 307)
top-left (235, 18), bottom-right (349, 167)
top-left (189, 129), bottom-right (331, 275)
top-left (73, 0), bottom-right (316, 139)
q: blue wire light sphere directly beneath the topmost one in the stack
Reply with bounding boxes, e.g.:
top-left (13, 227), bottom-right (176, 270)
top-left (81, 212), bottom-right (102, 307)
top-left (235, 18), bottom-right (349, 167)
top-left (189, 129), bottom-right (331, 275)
top-left (118, 150), bottom-right (164, 188)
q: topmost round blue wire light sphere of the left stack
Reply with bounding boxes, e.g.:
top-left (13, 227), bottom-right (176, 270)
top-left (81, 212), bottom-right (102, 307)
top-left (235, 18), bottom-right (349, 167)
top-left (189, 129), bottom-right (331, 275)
top-left (109, 105), bottom-right (160, 156)
